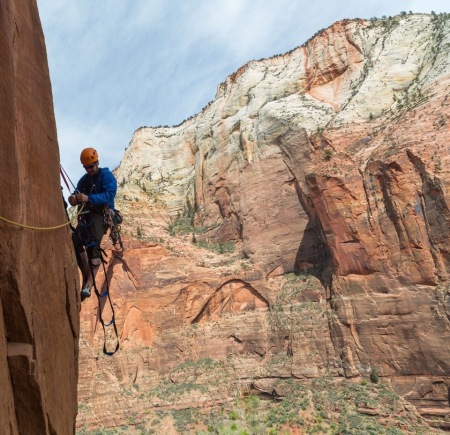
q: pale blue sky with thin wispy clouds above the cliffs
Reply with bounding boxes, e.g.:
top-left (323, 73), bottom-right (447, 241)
top-left (37, 0), bottom-right (450, 190)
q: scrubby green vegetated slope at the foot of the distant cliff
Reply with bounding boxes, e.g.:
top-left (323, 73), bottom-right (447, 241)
top-left (77, 376), bottom-right (436, 435)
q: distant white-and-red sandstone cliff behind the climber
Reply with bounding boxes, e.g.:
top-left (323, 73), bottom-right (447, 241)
top-left (79, 14), bottom-right (450, 432)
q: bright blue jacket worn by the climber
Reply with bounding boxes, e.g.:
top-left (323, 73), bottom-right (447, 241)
top-left (77, 168), bottom-right (117, 210)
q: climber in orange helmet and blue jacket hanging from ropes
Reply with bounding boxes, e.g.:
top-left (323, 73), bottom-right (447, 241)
top-left (68, 148), bottom-right (117, 301)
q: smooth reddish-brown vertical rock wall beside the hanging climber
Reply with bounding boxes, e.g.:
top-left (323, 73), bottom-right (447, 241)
top-left (0, 0), bottom-right (79, 434)
